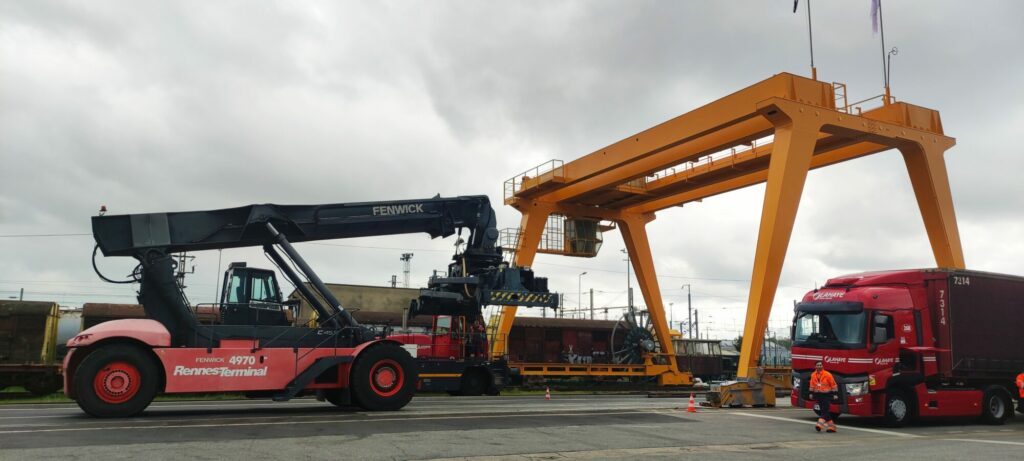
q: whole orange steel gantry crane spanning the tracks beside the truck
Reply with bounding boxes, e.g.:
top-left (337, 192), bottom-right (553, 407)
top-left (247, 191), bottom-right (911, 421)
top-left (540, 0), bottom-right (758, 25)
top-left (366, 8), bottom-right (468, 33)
top-left (492, 73), bottom-right (964, 400)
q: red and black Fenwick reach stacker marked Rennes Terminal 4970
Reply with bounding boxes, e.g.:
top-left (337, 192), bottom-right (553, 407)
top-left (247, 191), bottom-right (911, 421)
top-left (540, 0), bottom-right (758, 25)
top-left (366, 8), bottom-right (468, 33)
top-left (63, 196), bottom-right (557, 417)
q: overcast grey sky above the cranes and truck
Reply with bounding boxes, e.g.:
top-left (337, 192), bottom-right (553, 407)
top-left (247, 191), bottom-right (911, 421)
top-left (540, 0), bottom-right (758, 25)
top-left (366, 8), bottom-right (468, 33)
top-left (0, 0), bottom-right (1024, 337)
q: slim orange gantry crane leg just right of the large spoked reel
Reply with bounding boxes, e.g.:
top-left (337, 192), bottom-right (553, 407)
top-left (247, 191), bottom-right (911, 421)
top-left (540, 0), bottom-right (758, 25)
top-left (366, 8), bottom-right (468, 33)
top-left (617, 213), bottom-right (692, 385)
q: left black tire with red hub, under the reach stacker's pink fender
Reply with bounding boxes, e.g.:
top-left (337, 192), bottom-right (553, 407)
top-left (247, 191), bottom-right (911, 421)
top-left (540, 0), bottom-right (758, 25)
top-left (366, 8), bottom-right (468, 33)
top-left (72, 344), bottom-right (160, 418)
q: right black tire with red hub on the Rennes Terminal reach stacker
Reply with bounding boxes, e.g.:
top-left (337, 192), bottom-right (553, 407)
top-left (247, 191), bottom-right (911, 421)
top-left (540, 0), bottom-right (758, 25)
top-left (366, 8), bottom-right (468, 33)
top-left (348, 343), bottom-right (419, 411)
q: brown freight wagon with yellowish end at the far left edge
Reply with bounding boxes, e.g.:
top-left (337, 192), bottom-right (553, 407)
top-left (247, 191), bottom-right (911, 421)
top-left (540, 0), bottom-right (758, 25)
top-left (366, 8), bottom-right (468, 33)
top-left (0, 301), bottom-right (61, 395)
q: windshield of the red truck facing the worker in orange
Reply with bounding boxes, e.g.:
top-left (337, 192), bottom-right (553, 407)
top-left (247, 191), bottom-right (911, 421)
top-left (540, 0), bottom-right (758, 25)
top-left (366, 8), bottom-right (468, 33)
top-left (794, 311), bottom-right (867, 348)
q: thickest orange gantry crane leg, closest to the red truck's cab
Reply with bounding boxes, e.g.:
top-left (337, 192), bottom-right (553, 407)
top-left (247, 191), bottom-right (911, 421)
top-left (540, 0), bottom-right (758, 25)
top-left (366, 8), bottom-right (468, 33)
top-left (736, 109), bottom-right (820, 378)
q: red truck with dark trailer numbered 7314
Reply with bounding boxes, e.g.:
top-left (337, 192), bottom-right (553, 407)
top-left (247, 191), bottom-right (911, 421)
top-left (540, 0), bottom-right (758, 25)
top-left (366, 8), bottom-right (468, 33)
top-left (791, 269), bottom-right (1024, 425)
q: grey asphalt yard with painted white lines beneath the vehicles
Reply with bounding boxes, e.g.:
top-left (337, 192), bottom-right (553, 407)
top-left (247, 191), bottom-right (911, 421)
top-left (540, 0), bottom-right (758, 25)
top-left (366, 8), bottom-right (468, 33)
top-left (0, 393), bottom-right (1024, 461)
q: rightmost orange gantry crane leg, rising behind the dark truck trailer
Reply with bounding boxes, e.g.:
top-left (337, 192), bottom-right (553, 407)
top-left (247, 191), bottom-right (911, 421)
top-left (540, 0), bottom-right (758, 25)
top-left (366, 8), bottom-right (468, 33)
top-left (900, 142), bottom-right (966, 268)
